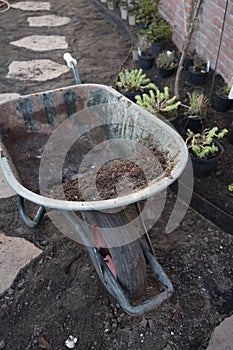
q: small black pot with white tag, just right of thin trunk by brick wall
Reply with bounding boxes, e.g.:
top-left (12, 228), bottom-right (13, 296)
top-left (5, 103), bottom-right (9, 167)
top-left (188, 55), bottom-right (209, 85)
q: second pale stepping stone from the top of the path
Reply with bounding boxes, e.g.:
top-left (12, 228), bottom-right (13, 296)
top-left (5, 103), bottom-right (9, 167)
top-left (27, 15), bottom-right (70, 27)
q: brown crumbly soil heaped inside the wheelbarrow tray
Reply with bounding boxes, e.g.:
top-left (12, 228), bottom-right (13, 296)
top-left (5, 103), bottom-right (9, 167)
top-left (61, 147), bottom-right (168, 201)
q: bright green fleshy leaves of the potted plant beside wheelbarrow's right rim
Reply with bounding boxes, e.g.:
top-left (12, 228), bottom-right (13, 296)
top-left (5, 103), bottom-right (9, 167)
top-left (186, 126), bottom-right (228, 159)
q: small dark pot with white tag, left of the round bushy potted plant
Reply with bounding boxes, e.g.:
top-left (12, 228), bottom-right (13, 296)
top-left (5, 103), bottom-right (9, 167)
top-left (138, 35), bottom-right (154, 70)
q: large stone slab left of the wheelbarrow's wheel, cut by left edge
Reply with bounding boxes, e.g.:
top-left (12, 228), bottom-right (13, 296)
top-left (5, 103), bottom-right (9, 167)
top-left (0, 232), bottom-right (42, 294)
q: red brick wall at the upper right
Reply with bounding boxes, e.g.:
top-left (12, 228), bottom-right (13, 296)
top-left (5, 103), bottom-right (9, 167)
top-left (160, 0), bottom-right (233, 82)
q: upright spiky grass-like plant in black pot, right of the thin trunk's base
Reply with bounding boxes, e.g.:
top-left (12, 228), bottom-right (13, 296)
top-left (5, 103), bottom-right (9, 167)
top-left (183, 90), bottom-right (209, 133)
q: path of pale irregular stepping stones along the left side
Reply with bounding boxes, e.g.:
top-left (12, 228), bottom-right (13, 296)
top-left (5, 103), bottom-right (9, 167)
top-left (0, 1), bottom-right (70, 294)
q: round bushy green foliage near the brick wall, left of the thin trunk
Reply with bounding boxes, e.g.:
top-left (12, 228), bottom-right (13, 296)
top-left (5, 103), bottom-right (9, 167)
top-left (141, 17), bottom-right (172, 43)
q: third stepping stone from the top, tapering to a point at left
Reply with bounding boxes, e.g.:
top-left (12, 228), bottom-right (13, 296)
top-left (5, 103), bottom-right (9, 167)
top-left (10, 35), bottom-right (68, 51)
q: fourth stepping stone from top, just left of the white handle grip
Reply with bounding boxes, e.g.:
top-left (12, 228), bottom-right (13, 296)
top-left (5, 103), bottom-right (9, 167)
top-left (6, 59), bottom-right (70, 81)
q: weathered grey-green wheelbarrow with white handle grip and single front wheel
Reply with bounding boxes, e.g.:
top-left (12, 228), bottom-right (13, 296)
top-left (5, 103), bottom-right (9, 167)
top-left (0, 54), bottom-right (188, 315)
